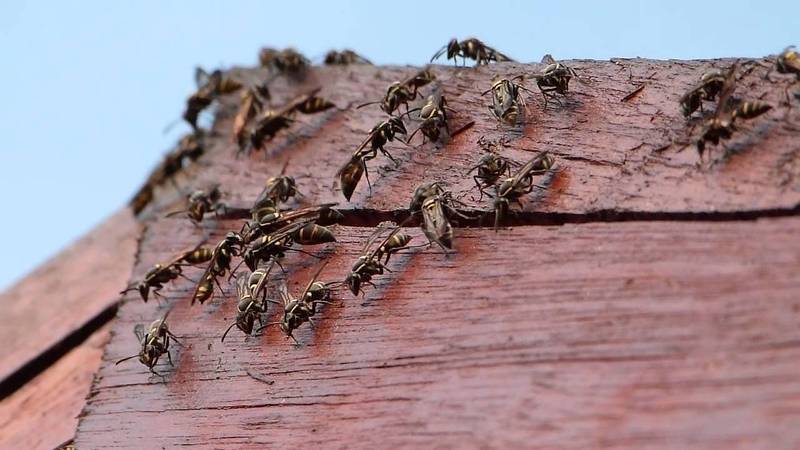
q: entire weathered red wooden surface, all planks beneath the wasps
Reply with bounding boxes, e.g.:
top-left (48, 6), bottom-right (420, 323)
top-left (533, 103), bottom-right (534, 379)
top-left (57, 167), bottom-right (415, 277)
top-left (0, 59), bottom-right (800, 448)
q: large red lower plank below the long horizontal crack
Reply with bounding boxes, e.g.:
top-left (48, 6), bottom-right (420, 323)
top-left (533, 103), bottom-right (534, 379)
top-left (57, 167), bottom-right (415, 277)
top-left (76, 217), bottom-right (800, 449)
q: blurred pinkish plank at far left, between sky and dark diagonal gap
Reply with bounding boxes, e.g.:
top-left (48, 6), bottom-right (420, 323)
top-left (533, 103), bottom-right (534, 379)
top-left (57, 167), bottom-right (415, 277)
top-left (0, 209), bottom-right (141, 388)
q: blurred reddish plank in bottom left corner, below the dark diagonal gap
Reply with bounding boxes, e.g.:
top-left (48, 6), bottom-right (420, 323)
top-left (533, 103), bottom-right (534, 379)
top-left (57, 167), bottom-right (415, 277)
top-left (0, 324), bottom-right (111, 450)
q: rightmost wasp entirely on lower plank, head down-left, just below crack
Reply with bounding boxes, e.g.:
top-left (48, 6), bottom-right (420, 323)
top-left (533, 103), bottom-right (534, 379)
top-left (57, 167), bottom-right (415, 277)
top-left (344, 222), bottom-right (411, 295)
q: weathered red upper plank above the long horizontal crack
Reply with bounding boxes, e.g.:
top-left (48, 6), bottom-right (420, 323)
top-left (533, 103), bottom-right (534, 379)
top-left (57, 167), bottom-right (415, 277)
top-left (134, 59), bottom-right (800, 227)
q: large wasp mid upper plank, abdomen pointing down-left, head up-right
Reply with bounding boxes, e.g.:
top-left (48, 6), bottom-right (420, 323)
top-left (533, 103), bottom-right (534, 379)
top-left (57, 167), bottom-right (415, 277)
top-left (336, 117), bottom-right (407, 201)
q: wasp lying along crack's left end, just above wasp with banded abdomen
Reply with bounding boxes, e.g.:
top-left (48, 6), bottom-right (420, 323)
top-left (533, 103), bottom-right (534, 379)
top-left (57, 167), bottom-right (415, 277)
top-left (242, 203), bottom-right (344, 243)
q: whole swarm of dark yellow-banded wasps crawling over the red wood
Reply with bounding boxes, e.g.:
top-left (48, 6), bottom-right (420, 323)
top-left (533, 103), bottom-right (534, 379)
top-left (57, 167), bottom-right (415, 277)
top-left (118, 38), bottom-right (800, 374)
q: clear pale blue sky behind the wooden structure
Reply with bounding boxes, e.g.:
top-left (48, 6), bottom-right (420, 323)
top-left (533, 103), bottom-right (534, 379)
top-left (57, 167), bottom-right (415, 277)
top-left (0, 0), bottom-right (800, 295)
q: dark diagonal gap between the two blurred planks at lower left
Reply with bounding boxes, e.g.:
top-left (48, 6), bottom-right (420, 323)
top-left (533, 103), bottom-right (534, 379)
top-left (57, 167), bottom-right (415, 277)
top-left (0, 303), bottom-right (119, 401)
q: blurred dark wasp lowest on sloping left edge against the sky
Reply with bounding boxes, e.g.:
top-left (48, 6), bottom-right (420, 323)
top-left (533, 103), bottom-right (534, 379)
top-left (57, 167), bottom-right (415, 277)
top-left (129, 130), bottom-right (205, 214)
